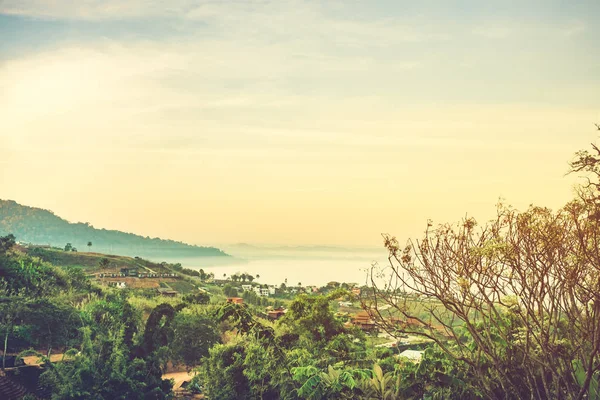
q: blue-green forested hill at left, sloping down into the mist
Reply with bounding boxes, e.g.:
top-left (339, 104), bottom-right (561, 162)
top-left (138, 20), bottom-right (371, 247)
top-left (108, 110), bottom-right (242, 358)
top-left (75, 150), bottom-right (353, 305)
top-left (0, 200), bottom-right (228, 257)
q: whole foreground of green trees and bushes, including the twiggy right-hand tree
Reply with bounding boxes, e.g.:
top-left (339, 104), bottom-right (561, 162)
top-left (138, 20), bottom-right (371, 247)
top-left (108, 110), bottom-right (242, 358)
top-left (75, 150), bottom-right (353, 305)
top-left (0, 139), bottom-right (600, 400)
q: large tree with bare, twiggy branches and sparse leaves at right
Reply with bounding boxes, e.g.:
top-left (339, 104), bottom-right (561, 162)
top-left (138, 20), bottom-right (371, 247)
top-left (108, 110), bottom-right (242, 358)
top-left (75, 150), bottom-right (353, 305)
top-left (362, 137), bottom-right (600, 400)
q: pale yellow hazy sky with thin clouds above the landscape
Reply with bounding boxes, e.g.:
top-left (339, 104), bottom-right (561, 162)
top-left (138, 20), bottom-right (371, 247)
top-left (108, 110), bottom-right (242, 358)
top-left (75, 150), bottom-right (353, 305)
top-left (0, 0), bottom-right (600, 246)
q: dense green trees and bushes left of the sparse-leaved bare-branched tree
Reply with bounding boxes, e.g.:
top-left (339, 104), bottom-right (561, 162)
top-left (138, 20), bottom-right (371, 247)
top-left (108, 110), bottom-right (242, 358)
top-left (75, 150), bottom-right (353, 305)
top-left (0, 231), bottom-right (454, 399)
